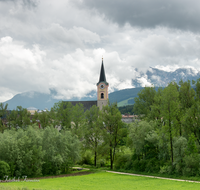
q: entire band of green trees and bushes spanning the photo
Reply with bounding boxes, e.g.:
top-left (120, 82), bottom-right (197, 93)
top-left (0, 79), bottom-right (200, 176)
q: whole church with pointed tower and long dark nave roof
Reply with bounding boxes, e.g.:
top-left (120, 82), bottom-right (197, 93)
top-left (70, 58), bottom-right (109, 111)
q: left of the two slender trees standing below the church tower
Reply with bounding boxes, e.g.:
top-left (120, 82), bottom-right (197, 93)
top-left (83, 106), bottom-right (103, 166)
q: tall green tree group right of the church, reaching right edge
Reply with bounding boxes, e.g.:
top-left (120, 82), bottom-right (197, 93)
top-left (116, 79), bottom-right (200, 176)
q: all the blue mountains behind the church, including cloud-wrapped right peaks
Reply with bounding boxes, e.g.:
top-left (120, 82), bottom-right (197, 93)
top-left (4, 68), bottom-right (200, 110)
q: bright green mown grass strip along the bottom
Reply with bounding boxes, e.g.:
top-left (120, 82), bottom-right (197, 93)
top-left (1, 172), bottom-right (200, 190)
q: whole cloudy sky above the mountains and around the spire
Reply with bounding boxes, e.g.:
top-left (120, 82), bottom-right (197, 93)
top-left (0, 0), bottom-right (200, 102)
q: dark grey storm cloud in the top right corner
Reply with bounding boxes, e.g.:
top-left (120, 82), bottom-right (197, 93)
top-left (79, 0), bottom-right (200, 31)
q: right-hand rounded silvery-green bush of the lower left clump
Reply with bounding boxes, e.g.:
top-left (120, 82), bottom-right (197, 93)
top-left (42, 126), bottom-right (79, 175)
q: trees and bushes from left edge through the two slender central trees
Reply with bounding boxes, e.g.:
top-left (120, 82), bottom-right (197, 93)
top-left (0, 102), bottom-right (127, 178)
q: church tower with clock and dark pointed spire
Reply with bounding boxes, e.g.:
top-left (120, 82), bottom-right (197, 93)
top-left (97, 58), bottom-right (109, 110)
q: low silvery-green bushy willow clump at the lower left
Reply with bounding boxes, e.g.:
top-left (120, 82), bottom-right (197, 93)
top-left (0, 125), bottom-right (80, 179)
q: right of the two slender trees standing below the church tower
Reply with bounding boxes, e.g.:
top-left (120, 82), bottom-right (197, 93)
top-left (101, 103), bottom-right (126, 169)
